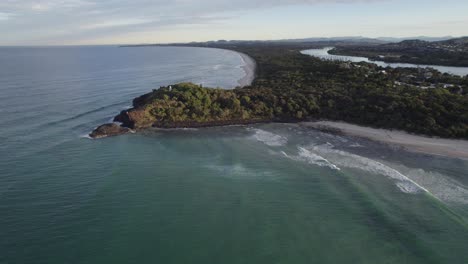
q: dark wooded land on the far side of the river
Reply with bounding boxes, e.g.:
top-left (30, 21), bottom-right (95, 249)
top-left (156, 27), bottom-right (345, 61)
top-left (330, 38), bottom-right (468, 67)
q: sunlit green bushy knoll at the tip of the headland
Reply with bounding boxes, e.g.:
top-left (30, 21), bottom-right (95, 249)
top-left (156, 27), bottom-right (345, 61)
top-left (117, 83), bottom-right (273, 128)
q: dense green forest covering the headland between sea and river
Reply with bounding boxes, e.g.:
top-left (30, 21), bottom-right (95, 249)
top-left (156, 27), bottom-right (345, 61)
top-left (107, 45), bottom-right (468, 138)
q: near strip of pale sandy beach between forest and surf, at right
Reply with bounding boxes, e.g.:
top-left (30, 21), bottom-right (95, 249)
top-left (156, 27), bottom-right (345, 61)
top-left (302, 121), bottom-right (468, 160)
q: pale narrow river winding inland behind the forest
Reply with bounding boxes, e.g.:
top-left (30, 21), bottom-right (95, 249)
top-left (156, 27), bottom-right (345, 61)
top-left (302, 47), bottom-right (468, 76)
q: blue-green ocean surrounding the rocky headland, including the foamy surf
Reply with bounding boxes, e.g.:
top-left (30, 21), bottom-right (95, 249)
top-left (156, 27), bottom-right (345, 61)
top-left (0, 47), bottom-right (468, 264)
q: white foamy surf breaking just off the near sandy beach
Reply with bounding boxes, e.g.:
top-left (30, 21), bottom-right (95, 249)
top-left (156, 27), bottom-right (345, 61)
top-left (245, 128), bottom-right (468, 204)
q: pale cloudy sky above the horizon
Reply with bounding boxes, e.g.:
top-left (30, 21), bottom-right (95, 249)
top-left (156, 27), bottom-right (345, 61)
top-left (0, 0), bottom-right (468, 46)
